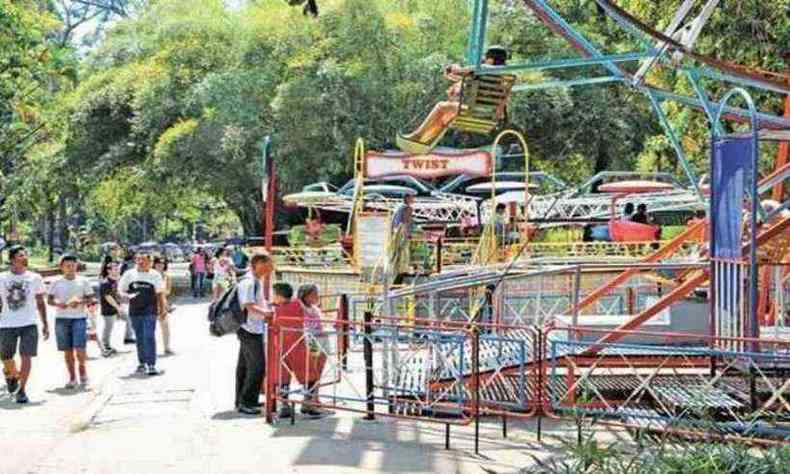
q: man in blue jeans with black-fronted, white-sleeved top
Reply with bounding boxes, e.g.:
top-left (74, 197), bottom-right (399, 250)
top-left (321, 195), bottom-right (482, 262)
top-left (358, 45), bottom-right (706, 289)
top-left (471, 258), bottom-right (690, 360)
top-left (118, 252), bottom-right (167, 375)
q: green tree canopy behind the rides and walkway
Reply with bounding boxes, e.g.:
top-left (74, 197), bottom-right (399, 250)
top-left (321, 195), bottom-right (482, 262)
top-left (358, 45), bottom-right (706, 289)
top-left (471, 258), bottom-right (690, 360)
top-left (0, 0), bottom-right (790, 252)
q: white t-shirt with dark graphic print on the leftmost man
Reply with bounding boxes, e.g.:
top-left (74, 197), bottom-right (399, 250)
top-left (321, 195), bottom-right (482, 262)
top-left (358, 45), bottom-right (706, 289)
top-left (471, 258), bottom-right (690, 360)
top-left (0, 271), bottom-right (45, 328)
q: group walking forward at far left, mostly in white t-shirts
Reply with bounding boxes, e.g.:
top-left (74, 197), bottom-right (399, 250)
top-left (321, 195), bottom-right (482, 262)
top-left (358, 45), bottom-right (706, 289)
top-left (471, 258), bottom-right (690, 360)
top-left (0, 246), bottom-right (172, 404)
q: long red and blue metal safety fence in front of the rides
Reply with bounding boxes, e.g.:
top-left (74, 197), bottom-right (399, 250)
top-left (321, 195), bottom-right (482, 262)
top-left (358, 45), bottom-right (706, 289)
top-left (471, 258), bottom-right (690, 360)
top-left (266, 295), bottom-right (790, 447)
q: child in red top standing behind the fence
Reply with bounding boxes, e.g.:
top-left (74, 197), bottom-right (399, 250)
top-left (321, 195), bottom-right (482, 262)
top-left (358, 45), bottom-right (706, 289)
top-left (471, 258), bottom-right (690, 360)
top-left (272, 283), bottom-right (326, 418)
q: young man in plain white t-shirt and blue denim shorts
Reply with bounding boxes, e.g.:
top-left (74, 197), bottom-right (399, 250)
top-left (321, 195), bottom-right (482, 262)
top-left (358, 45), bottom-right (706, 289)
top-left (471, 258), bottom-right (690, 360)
top-left (48, 254), bottom-right (93, 389)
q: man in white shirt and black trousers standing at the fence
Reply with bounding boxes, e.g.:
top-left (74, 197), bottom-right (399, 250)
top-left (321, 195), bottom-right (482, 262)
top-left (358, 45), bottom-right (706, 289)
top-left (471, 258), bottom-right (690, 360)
top-left (236, 253), bottom-right (274, 415)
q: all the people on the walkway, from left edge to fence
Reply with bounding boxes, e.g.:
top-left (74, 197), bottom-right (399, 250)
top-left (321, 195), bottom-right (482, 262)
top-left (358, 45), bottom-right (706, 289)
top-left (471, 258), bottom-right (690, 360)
top-left (0, 246), bottom-right (329, 417)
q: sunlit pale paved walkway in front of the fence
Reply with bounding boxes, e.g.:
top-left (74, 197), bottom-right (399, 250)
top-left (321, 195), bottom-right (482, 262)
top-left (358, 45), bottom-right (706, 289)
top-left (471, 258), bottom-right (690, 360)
top-left (0, 301), bottom-right (632, 474)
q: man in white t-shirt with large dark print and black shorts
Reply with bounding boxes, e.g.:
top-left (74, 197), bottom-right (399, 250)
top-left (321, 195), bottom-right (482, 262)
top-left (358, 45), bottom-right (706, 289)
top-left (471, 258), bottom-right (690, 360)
top-left (0, 245), bottom-right (49, 403)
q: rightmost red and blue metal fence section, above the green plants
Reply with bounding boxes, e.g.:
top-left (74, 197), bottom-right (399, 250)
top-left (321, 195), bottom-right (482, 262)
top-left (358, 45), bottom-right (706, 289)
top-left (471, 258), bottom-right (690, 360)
top-left (544, 327), bottom-right (790, 443)
